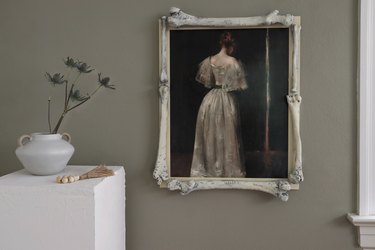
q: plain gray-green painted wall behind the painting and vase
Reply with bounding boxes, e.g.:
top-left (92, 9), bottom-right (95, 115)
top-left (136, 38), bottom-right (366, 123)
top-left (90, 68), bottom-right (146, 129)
top-left (0, 0), bottom-right (358, 250)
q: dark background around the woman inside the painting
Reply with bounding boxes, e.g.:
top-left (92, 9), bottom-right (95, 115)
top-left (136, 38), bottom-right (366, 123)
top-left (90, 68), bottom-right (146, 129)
top-left (170, 28), bottom-right (289, 178)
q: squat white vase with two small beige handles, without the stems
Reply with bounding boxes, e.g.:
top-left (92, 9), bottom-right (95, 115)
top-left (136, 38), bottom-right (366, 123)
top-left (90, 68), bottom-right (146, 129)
top-left (16, 133), bottom-right (74, 175)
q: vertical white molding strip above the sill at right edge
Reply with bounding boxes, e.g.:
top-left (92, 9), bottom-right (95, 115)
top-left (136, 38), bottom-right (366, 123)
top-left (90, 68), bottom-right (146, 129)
top-left (358, 0), bottom-right (375, 215)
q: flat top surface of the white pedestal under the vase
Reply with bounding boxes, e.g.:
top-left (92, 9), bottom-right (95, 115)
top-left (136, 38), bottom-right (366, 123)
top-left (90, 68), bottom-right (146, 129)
top-left (0, 166), bottom-right (123, 191)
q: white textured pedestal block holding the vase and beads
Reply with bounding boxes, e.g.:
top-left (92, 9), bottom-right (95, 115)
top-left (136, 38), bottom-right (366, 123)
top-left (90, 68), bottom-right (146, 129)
top-left (0, 166), bottom-right (125, 250)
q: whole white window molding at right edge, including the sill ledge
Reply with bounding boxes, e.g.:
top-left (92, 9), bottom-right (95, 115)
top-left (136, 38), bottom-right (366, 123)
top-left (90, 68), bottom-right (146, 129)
top-left (348, 0), bottom-right (375, 249)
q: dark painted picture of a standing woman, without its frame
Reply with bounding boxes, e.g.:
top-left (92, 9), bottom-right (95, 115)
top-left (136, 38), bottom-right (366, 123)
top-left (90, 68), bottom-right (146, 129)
top-left (170, 28), bottom-right (290, 178)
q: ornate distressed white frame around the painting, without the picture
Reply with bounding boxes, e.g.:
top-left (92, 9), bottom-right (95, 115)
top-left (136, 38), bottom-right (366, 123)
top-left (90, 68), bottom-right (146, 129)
top-left (153, 7), bottom-right (303, 201)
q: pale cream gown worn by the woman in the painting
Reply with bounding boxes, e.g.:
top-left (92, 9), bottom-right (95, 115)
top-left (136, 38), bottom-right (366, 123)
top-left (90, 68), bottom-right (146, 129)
top-left (190, 57), bottom-right (247, 177)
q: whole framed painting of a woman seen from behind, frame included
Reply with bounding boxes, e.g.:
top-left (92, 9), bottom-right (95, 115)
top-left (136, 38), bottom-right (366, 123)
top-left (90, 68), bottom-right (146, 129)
top-left (153, 8), bottom-right (303, 201)
